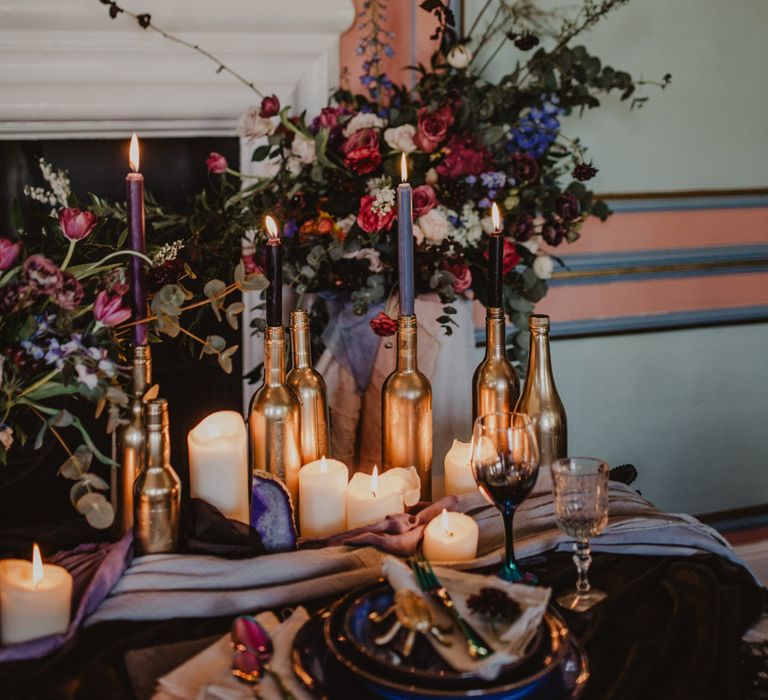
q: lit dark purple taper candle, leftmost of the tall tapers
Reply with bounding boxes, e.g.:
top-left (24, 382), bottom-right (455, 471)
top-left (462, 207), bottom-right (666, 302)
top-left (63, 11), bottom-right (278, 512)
top-left (125, 134), bottom-right (147, 346)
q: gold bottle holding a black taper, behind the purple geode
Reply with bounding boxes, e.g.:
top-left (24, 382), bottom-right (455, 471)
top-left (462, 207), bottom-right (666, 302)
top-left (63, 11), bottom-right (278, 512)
top-left (248, 326), bottom-right (301, 512)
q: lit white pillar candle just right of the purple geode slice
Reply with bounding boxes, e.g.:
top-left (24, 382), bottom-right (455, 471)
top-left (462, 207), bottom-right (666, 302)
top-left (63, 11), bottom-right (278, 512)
top-left (299, 457), bottom-right (349, 537)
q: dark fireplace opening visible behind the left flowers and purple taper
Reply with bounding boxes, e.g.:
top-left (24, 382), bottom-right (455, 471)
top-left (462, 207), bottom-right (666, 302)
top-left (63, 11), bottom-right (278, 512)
top-left (0, 138), bottom-right (242, 534)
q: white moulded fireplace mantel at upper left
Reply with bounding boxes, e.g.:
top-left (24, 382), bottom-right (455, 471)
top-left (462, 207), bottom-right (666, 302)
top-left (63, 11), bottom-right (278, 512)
top-left (0, 0), bottom-right (354, 139)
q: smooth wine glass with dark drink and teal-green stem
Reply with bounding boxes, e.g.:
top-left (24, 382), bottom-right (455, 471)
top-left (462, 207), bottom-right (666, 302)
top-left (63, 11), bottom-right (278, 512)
top-left (470, 413), bottom-right (539, 583)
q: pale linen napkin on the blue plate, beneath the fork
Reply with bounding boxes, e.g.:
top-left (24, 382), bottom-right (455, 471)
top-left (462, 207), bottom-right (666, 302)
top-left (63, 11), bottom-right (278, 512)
top-left (381, 557), bottom-right (551, 680)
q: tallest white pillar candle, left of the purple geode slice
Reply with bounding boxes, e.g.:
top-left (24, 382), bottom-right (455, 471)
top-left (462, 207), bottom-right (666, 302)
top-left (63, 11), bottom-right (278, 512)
top-left (187, 411), bottom-right (250, 523)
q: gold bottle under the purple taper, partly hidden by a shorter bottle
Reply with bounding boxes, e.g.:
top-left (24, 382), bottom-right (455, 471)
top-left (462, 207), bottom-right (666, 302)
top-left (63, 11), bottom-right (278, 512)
top-left (111, 345), bottom-right (152, 539)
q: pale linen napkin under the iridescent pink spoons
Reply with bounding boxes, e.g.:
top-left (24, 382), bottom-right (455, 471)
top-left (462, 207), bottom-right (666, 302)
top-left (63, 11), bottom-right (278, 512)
top-left (153, 607), bottom-right (312, 700)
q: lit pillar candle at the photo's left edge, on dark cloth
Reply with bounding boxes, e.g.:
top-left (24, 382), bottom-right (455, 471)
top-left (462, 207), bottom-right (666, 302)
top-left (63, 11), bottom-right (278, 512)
top-left (0, 545), bottom-right (72, 646)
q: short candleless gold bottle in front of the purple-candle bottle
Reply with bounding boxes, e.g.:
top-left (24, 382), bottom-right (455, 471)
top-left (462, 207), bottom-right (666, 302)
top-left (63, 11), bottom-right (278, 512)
top-left (133, 399), bottom-right (181, 554)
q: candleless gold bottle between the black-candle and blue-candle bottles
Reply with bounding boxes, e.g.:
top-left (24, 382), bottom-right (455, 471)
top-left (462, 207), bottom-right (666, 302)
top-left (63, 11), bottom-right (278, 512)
top-left (286, 310), bottom-right (330, 464)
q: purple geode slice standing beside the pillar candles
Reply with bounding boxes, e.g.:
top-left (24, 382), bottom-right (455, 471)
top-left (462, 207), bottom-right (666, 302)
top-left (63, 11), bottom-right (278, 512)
top-left (251, 470), bottom-right (298, 553)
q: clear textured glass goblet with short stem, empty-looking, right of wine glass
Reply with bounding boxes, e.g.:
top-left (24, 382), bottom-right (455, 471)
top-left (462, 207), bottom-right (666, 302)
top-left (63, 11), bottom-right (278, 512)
top-left (552, 457), bottom-right (610, 612)
